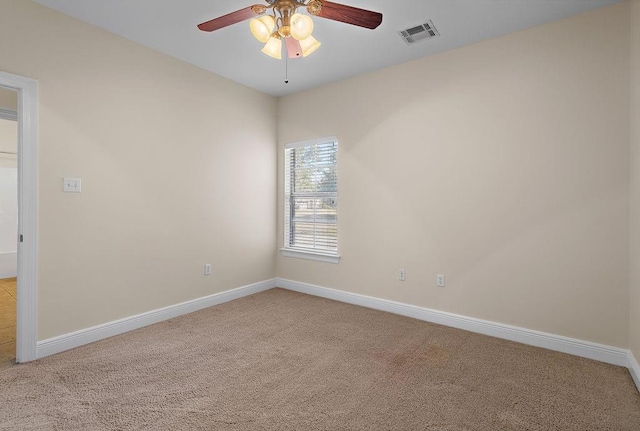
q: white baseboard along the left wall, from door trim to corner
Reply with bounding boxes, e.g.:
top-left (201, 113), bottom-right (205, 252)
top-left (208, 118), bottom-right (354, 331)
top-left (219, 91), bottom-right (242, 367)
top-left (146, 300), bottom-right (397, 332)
top-left (37, 279), bottom-right (276, 359)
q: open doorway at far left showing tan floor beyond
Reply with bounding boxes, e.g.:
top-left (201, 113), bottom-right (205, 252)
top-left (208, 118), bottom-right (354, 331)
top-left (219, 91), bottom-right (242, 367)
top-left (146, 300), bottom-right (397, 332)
top-left (0, 88), bottom-right (18, 367)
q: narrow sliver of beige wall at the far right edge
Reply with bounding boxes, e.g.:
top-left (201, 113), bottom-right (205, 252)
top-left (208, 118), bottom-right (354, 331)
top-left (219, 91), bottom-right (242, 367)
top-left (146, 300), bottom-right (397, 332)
top-left (629, 0), bottom-right (640, 361)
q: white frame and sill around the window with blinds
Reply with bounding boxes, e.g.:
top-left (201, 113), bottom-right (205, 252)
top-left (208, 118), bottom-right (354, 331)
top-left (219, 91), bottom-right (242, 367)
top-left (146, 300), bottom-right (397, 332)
top-left (280, 136), bottom-right (340, 264)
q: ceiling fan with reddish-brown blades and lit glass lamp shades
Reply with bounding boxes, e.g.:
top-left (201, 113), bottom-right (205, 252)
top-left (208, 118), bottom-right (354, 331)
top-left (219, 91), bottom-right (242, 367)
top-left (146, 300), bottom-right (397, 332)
top-left (198, 0), bottom-right (382, 59)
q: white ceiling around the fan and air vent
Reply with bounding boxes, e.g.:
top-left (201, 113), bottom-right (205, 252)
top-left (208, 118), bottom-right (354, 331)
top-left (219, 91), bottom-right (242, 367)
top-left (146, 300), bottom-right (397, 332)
top-left (36, 0), bottom-right (621, 96)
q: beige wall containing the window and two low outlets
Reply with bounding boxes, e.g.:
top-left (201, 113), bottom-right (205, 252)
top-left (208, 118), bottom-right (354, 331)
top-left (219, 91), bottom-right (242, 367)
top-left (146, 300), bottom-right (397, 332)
top-left (277, 3), bottom-right (629, 348)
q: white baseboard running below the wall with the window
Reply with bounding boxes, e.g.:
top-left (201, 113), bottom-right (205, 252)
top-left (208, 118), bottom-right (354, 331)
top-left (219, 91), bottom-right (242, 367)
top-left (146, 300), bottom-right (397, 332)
top-left (276, 278), bottom-right (629, 367)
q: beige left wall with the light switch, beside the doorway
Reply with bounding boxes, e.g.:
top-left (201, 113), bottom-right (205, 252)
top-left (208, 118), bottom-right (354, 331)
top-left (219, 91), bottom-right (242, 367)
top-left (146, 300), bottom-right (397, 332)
top-left (0, 0), bottom-right (276, 339)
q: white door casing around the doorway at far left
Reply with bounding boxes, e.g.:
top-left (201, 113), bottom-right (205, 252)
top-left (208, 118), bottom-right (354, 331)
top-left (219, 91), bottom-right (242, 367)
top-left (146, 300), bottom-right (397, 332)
top-left (0, 72), bottom-right (38, 362)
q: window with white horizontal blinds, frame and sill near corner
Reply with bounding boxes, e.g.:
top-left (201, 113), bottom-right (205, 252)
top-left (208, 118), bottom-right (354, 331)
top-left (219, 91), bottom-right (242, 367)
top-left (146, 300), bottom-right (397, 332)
top-left (282, 138), bottom-right (339, 263)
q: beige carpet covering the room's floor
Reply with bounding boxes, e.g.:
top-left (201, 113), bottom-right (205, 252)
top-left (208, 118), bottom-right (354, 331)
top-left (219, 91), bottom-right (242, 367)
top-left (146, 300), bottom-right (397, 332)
top-left (0, 289), bottom-right (640, 431)
